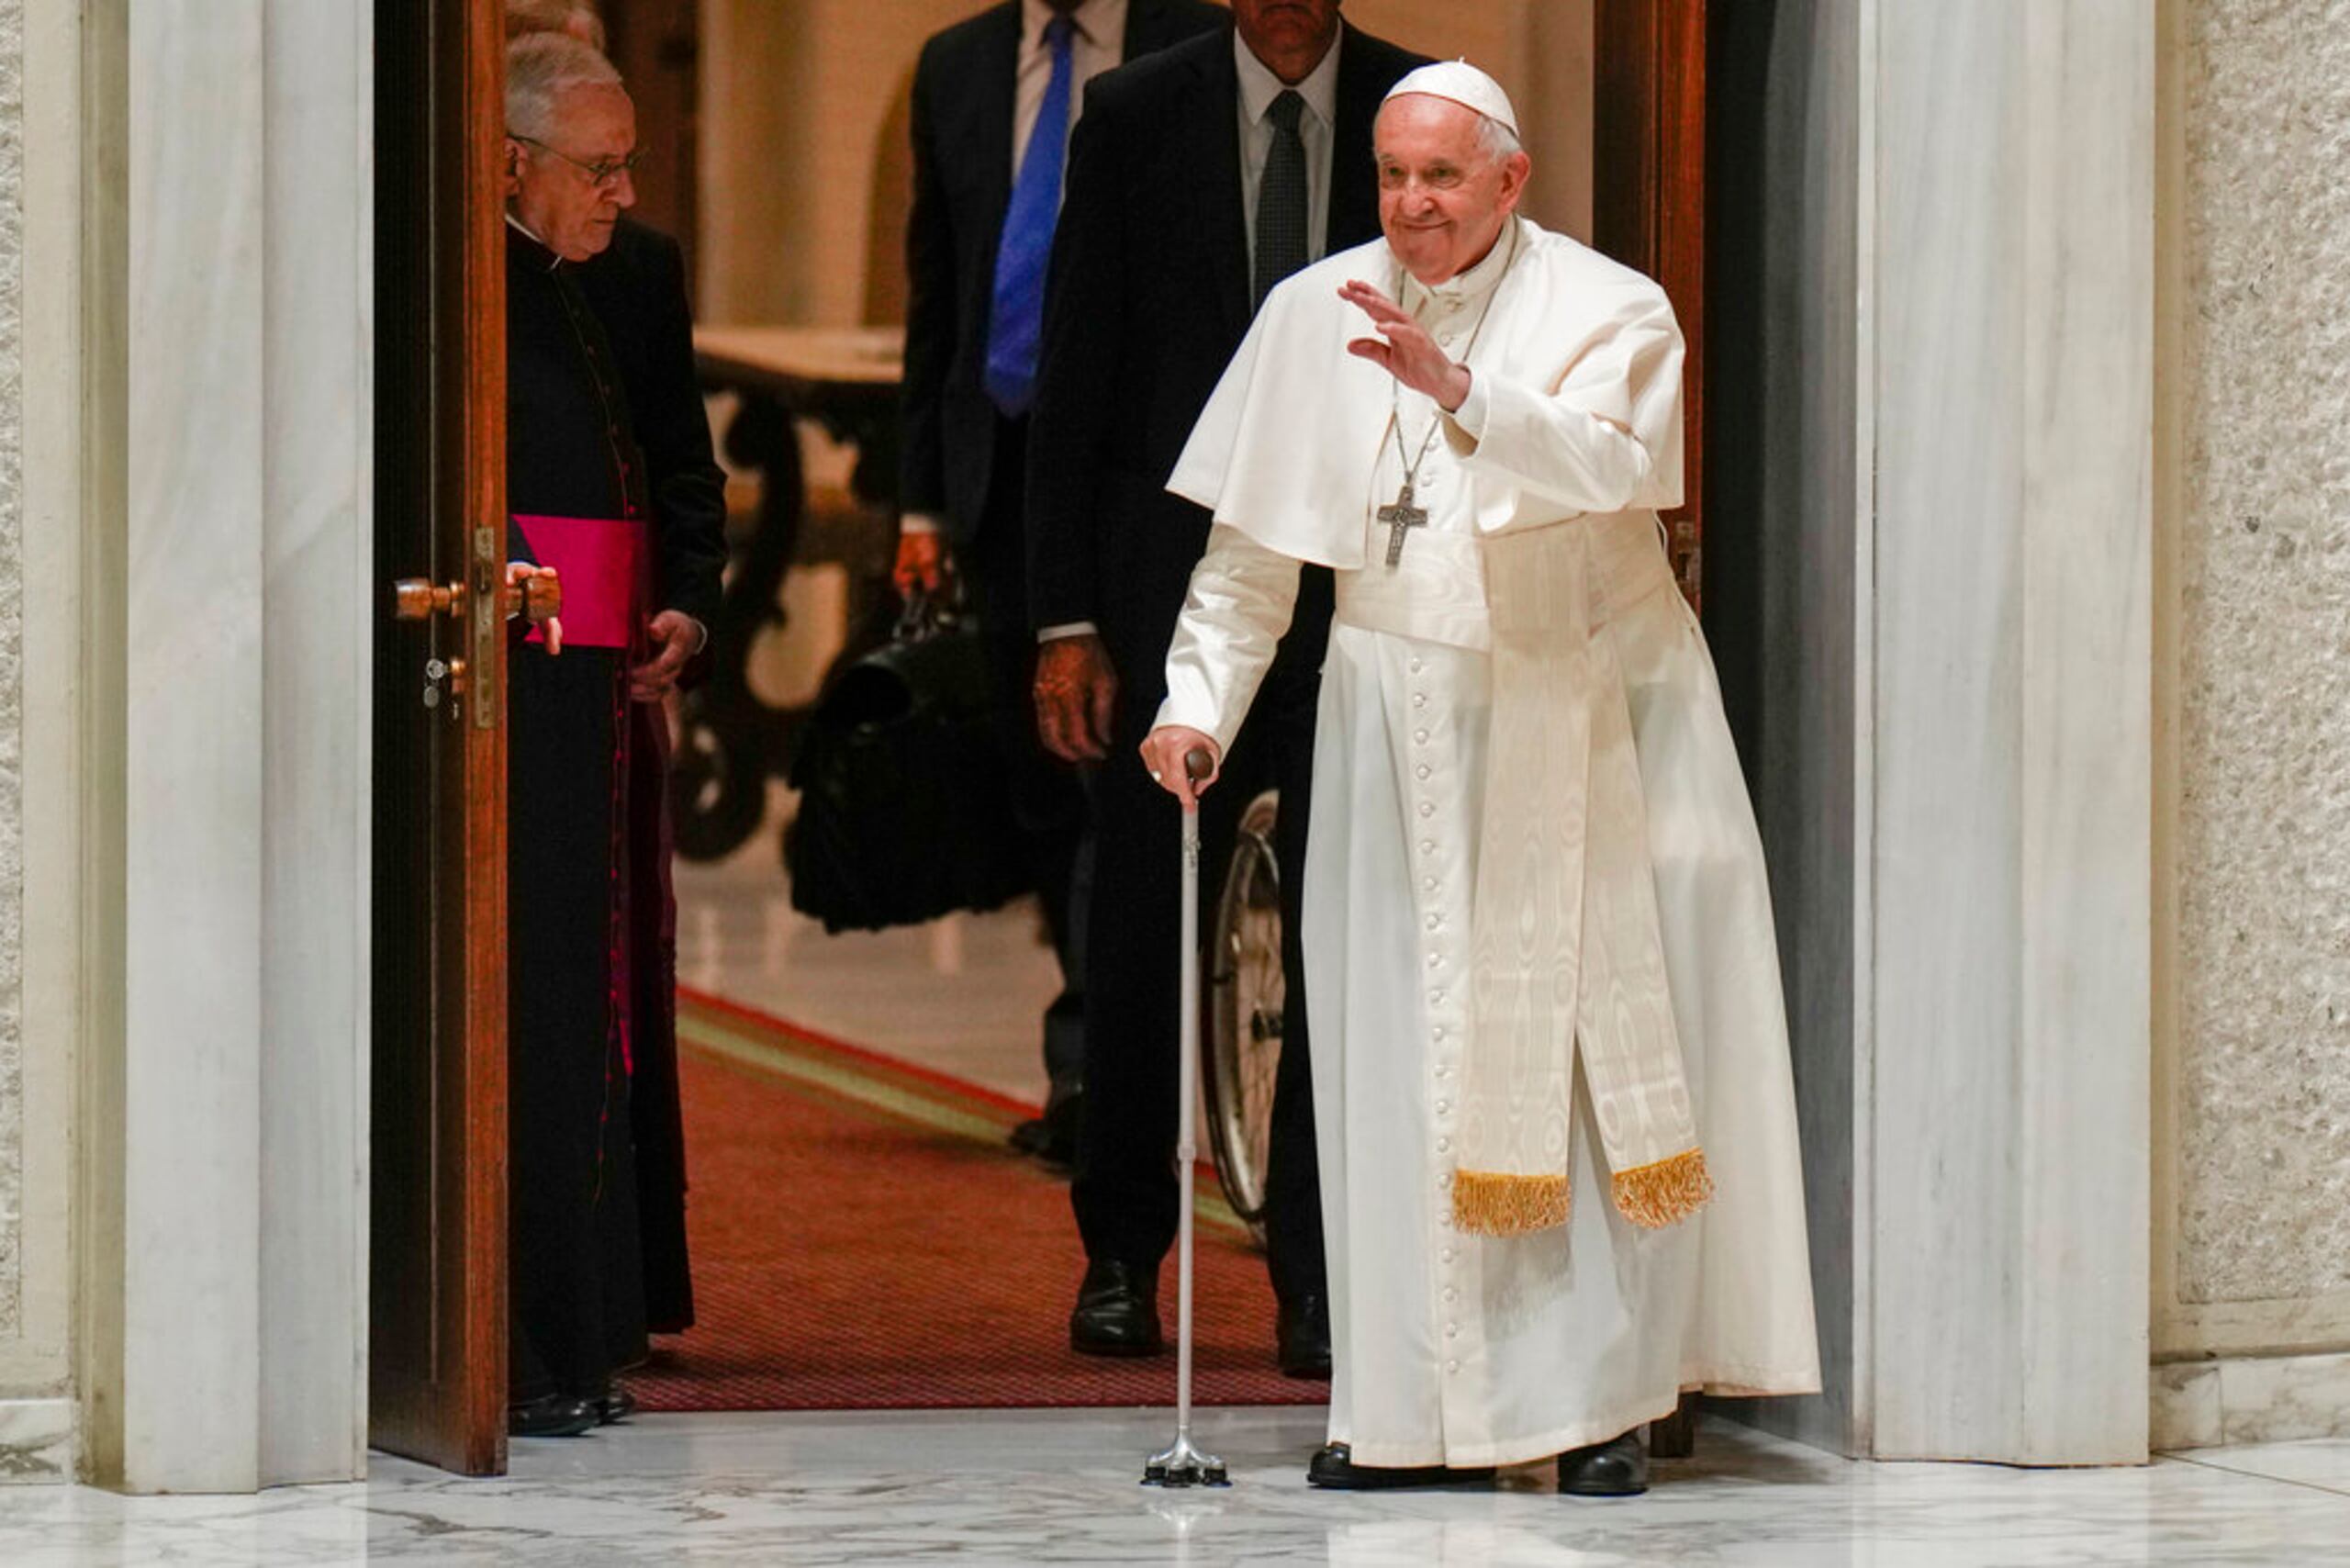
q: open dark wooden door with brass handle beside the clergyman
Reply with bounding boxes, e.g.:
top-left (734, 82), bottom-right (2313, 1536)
top-left (369, 0), bottom-right (508, 1474)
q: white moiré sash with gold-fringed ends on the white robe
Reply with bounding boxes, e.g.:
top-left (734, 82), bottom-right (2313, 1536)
top-left (1452, 512), bottom-right (1713, 1237)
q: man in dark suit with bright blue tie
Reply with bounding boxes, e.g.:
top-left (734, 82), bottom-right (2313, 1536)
top-left (895, 0), bottom-right (1222, 1164)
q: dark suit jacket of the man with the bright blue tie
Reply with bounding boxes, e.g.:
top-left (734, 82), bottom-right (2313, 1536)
top-left (898, 0), bottom-right (1229, 543)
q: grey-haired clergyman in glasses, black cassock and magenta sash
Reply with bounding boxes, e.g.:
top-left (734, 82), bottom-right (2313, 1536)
top-left (503, 33), bottom-right (705, 1437)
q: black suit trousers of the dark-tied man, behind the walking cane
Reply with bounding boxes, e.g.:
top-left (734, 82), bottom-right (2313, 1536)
top-left (1069, 609), bottom-right (1327, 1303)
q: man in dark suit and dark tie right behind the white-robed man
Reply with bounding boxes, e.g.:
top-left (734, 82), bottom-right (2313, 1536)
top-left (1029, 0), bottom-right (1424, 1378)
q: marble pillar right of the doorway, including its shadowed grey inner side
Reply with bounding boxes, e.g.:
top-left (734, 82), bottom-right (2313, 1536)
top-left (1708, 0), bottom-right (2155, 1464)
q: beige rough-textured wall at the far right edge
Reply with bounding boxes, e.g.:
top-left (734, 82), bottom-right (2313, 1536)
top-left (2153, 0), bottom-right (2350, 1363)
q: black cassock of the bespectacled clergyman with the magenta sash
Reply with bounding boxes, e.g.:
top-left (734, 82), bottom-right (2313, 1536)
top-left (505, 228), bottom-right (675, 1399)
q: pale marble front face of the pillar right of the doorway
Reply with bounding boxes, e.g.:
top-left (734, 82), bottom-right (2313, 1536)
top-left (1862, 0), bottom-right (2153, 1462)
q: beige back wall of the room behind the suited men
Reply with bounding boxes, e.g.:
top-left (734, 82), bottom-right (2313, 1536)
top-left (700, 0), bottom-right (1594, 324)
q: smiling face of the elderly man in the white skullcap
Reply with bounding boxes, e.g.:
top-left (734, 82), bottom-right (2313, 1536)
top-left (1372, 92), bottom-right (1532, 286)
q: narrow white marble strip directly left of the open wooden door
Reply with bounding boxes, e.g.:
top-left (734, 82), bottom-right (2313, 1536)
top-left (259, 0), bottom-right (381, 1484)
